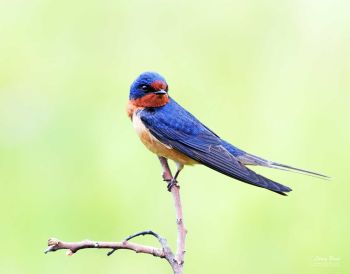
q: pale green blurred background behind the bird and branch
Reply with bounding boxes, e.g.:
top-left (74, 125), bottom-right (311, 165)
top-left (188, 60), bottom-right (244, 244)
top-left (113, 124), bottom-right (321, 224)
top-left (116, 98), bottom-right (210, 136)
top-left (0, 0), bottom-right (350, 274)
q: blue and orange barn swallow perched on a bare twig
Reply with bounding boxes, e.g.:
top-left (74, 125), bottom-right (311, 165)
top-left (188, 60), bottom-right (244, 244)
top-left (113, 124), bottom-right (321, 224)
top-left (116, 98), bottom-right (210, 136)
top-left (127, 72), bottom-right (328, 195)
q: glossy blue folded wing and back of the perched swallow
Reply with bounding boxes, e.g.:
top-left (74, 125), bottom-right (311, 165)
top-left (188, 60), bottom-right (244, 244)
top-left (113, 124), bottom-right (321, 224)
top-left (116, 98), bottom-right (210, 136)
top-left (139, 100), bottom-right (291, 195)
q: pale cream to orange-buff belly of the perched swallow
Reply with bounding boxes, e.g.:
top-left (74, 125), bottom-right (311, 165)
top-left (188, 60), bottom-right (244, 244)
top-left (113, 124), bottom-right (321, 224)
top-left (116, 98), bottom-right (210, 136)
top-left (132, 113), bottom-right (197, 165)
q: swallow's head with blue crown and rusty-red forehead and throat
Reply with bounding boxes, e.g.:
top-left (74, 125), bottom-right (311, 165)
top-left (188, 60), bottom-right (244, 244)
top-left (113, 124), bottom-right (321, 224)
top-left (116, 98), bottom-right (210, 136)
top-left (129, 72), bottom-right (169, 107)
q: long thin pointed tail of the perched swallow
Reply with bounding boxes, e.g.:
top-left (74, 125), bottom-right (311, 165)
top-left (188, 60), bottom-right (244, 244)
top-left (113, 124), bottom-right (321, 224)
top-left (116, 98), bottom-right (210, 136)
top-left (237, 153), bottom-right (330, 180)
